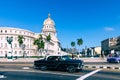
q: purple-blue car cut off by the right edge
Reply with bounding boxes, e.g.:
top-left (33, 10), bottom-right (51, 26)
top-left (107, 53), bottom-right (120, 63)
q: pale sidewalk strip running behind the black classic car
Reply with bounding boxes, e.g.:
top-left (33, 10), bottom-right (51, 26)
top-left (0, 58), bottom-right (106, 62)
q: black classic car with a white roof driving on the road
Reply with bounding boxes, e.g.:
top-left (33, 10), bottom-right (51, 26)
top-left (34, 55), bottom-right (84, 73)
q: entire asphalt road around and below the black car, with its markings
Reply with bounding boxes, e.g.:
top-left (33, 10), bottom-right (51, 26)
top-left (0, 62), bottom-right (120, 80)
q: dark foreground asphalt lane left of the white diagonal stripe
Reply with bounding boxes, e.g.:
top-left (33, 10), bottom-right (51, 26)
top-left (0, 71), bottom-right (77, 80)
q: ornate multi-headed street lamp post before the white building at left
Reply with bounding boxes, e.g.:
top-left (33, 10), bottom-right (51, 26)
top-left (6, 36), bottom-right (13, 60)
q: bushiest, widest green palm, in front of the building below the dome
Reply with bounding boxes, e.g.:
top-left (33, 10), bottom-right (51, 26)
top-left (33, 34), bottom-right (45, 54)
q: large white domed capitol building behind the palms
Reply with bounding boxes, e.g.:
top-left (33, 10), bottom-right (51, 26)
top-left (0, 14), bottom-right (60, 57)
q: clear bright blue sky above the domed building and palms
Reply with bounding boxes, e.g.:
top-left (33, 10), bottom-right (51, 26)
top-left (0, 0), bottom-right (120, 48)
